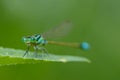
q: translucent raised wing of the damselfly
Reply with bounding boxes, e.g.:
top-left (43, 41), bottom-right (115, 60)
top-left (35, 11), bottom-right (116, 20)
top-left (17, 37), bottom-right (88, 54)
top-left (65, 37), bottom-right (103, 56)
top-left (42, 21), bottom-right (72, 38)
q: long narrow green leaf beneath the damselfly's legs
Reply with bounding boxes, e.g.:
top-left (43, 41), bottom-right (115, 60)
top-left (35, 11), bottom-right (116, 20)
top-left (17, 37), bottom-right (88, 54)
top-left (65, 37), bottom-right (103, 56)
top-left (0, 47), bottom-right (90, 66)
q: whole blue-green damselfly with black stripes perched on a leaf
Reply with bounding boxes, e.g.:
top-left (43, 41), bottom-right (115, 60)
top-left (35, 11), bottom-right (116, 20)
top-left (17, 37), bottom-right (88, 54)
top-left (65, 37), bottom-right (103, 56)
top-left (22, 21), bottom-right (90, 56)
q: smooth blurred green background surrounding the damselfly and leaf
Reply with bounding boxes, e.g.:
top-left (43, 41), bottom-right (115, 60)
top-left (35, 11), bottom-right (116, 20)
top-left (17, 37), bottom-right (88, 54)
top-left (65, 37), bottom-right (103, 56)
top-left (0, 0), bottom-right (120, 80)
